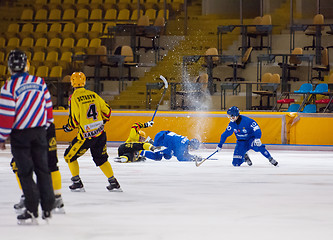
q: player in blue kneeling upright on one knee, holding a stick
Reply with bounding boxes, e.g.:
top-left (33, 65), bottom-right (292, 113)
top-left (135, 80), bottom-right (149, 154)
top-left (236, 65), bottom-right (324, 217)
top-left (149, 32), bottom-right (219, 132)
top-left (216, 106), bottom-right (278, 166)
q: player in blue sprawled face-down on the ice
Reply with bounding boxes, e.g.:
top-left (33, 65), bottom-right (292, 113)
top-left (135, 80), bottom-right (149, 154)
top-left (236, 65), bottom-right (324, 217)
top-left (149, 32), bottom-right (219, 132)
top-left (143, 131), bottom-right (202, 162)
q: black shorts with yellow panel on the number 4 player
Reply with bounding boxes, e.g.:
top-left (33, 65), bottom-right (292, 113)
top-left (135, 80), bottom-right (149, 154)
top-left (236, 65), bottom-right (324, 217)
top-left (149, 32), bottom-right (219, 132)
top-left (64, 132), bottom-right (109, 166)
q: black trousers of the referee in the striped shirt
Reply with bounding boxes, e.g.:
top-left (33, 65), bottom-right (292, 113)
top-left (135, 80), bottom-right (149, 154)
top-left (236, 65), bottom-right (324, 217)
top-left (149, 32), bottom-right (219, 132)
top-left (10, 127), bottom-right (54, 213)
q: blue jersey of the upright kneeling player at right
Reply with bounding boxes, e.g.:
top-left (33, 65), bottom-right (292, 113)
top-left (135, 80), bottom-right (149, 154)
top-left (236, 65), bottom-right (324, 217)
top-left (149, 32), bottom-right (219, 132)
top-left (218, 115), bottom-right (261, 147)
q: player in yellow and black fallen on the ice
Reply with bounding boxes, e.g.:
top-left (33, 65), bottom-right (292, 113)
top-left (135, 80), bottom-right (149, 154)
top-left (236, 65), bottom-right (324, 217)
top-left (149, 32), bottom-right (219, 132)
top-left (115, 121), bottom-right (161, 163)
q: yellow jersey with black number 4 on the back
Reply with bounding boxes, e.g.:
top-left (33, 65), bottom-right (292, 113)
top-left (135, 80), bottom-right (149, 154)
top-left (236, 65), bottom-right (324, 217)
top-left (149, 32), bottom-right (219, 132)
top-left (68, 88), bottom-right (111, 140)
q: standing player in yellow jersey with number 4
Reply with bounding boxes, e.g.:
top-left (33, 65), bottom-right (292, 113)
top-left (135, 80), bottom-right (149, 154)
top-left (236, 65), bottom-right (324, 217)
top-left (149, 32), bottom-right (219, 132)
top-left (63, 72), bottom-right (122, 192)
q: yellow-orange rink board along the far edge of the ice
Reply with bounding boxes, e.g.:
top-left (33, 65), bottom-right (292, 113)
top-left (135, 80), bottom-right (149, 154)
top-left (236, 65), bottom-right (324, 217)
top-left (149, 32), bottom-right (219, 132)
top-left (54, 110), bottom-right (333, 145)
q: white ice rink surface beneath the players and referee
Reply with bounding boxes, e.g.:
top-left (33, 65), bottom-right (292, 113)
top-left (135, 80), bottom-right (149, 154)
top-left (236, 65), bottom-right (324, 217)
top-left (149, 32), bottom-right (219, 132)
top-left (0, 145), bottom-right (333, 240)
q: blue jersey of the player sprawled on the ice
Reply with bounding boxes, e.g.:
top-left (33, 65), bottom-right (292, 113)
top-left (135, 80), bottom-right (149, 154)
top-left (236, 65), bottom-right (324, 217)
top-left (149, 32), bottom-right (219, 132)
top-left (154, 131), bottom-right (194, 161)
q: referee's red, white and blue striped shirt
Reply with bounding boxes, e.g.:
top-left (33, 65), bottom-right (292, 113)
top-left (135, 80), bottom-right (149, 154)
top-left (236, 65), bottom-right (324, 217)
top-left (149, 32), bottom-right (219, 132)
top-left (0, 72), bottom-right (53, 141)
